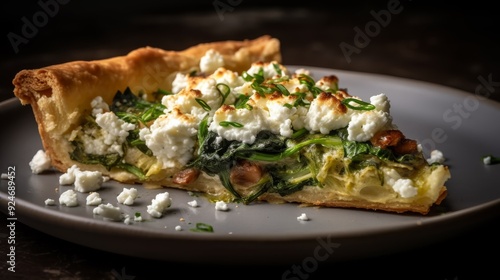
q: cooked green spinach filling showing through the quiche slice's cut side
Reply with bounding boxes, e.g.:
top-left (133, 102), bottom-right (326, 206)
top-left (70, 88), bottom-right (425, 204)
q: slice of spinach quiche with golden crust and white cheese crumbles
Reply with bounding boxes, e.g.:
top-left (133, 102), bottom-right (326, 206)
top-left (13, 35), bottom-right (450, 214)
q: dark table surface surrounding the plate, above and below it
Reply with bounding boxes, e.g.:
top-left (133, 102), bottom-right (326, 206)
top-left (0, 0), bottom-right (500, 279)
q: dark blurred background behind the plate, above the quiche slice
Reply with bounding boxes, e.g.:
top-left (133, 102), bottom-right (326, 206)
top-left (0, 0), bottom-right (500, 103)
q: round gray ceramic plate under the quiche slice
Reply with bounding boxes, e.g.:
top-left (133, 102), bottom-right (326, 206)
top-left (0, 66), bottom-right (500, 264)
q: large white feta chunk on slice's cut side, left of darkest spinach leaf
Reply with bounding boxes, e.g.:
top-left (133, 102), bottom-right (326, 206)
top-left (139, 110), bottom-right (198, 168)
